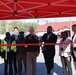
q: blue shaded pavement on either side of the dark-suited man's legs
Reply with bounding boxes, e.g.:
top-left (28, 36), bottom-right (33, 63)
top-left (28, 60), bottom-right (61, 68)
top-left (37, 63), bottom-right (62, 75)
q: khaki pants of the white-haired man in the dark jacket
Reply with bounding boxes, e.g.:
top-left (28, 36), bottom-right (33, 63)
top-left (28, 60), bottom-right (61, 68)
top-left (26, 52), bottom-right (37, 75)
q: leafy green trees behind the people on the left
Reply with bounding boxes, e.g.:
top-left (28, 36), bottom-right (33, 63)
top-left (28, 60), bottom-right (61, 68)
top-left (0, 20), bottom-right (41, 34)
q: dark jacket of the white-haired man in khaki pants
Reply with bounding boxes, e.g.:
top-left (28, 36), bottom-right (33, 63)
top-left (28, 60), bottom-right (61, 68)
top-left (25, 34), bottom-right (40, 53)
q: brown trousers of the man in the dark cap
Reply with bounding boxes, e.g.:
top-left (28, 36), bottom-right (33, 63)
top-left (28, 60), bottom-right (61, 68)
top-left (17, 53), bottom-right (26, 74)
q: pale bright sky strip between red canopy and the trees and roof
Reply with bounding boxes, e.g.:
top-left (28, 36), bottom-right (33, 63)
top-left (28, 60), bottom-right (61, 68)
top-left (7, 17), bottom-right (76, 25)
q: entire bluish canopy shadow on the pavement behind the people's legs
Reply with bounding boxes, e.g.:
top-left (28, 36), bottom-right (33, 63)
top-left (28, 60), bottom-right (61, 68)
top-left (0, 62), bottom-right (62, 75)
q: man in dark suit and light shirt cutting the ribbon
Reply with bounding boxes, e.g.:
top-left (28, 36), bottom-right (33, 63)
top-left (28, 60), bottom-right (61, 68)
top-left (42, 26), bottom-right (57, 75)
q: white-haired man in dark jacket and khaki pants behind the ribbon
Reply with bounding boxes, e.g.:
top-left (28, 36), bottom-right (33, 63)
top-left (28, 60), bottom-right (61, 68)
top-left (25, 27), bottom-right (40, 75)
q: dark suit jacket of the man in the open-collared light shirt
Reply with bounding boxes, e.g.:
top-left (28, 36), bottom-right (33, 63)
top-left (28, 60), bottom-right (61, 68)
top-left (42, 33), bottom-right (57, 56)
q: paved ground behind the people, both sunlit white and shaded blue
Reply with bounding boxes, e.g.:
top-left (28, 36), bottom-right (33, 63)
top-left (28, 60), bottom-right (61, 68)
top-left (0, 46), bottom-right (76, 75)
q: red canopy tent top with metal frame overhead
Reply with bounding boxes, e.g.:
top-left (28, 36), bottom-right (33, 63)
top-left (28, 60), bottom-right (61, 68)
top-left (0, 0), bottom-right (76, 20)
